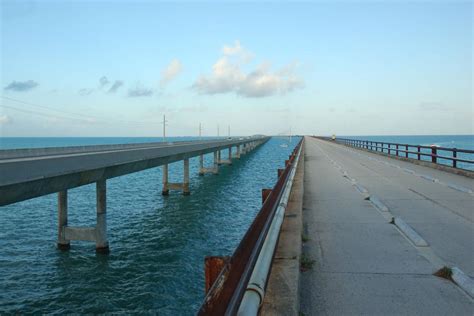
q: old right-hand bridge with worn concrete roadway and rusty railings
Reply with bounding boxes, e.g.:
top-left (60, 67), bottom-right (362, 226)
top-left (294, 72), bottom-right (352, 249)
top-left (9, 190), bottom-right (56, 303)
top-left (199, 137), bottom-right (474, 315)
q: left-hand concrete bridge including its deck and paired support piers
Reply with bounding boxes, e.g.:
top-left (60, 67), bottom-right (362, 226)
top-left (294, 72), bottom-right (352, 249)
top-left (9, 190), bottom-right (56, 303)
top-left (0, 136), bottom-right (268, 252)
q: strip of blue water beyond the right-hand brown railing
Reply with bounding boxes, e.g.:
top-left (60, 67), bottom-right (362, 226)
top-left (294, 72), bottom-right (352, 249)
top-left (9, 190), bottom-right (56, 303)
top-left (340, 135), bottom-right (474, 170)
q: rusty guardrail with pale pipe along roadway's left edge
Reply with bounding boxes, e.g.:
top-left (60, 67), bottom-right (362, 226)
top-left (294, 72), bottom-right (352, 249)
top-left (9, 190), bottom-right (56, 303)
top-left (198, 139), bottom-right (303, 315)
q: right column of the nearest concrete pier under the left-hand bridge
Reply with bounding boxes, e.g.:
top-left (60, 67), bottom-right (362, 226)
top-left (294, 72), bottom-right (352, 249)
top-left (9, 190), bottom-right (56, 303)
top-left (95, 180), bottom-right (109, 253)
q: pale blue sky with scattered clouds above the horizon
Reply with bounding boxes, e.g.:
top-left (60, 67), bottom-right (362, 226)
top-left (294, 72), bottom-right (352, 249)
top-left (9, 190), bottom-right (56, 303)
top-left (0, 0), bottom-right (474, 137)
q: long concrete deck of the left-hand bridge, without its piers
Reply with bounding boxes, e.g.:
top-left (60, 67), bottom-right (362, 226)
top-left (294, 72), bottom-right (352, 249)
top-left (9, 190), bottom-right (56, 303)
top-left (0, 137), bottom-right (266, 206)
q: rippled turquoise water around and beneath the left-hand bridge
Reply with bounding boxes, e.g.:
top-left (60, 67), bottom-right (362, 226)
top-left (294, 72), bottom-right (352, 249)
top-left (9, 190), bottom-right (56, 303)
top-left (0, 138), bottom-right (298, 315)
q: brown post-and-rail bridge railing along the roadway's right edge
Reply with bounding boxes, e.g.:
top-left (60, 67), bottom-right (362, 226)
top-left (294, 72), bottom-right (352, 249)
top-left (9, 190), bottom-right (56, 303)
top-left (323, 137), bottom-right (474, 170)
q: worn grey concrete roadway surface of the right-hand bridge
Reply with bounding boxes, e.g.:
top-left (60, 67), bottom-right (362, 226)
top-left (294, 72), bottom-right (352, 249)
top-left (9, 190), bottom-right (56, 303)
top-left (300, 137), bottom-right (474, 315)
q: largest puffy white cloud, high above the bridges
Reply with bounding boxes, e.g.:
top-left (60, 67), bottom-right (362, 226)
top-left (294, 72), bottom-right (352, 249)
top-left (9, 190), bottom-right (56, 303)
top-left (192, 41), bottom-right (304, 98)
